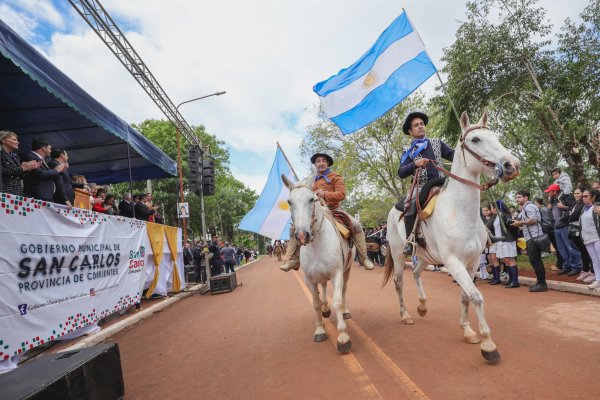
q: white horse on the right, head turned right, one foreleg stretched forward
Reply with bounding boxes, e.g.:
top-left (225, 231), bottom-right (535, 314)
top-left (383, 112), bottom-right (520, 363)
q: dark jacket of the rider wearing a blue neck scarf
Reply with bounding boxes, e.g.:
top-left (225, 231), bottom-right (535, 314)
top-left (398, 138), bottom-right (454, 186)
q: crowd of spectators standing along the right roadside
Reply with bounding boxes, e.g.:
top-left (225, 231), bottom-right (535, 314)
top-left (480, 168), bottom-right (600, 292)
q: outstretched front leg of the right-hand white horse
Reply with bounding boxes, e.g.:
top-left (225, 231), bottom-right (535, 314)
top-left (446, 257), bottom-right (500, 364)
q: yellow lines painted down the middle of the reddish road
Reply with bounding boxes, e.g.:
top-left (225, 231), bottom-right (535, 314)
top-left (294, 271), bottom-right (429, 400)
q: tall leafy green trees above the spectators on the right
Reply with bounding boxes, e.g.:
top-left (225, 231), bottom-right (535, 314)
top-left (432, 0), bottom-right (600, 188)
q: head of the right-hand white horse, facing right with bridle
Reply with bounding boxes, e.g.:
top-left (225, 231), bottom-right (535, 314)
top-left (454, 111), bottom-right (521, 182)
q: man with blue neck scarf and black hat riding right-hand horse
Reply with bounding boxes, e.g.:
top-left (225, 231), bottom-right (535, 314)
top-left (398, 112), bottom-right (454, 255)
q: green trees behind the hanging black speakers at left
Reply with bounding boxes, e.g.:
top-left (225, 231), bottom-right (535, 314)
top-left (112, 120), bottom-right (258, 247)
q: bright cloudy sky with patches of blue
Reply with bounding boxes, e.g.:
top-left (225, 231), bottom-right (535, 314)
top-left (0, 0), bottom-right (588, 193)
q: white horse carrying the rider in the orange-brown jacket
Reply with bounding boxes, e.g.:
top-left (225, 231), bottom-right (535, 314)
top-left (281, 174), bottom-right (355, 354)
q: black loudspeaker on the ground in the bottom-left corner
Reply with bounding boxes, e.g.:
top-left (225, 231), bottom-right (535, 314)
top-left (0, 343), bottom-right (125, 400)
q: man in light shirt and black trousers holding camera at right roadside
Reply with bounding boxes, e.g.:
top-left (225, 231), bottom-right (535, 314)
top-left (512, 190), bottom-right (550, 292)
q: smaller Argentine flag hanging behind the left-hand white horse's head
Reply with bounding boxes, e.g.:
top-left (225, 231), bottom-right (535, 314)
top-left (239, 146), bottom-right (297, 240)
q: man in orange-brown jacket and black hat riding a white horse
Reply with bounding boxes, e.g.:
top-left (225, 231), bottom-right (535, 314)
top-left (279, 153), bottom-right (373, 272)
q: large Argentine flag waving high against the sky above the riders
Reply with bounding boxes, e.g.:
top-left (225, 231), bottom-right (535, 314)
top-left (313, 12), bottom-right (436, 134)
